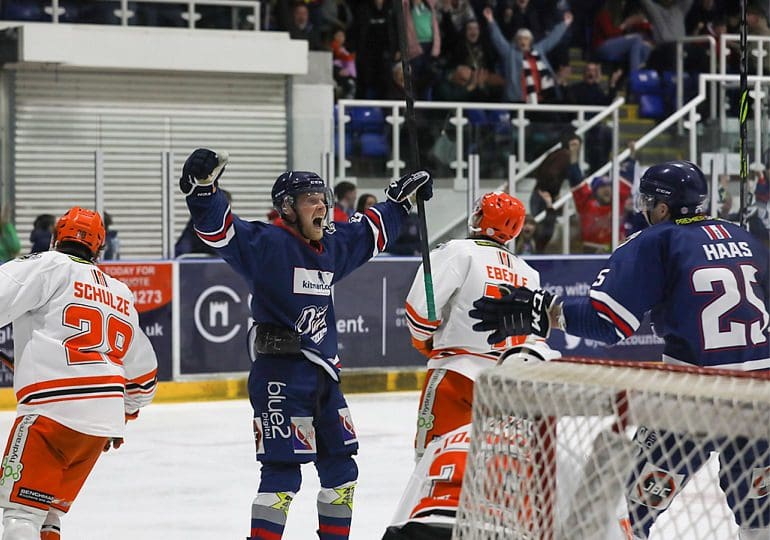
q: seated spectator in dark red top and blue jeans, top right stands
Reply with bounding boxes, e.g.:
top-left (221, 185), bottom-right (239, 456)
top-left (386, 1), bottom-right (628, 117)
top-left (593, 0), bottom-right (652, 76)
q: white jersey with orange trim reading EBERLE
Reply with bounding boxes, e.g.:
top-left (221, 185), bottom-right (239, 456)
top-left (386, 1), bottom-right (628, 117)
top-left (406, 238), bottom-right (544, 380)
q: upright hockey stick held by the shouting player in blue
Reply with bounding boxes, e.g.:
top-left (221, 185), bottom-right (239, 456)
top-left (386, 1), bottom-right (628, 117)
top-left (393, 0), bottom-right (436, 321)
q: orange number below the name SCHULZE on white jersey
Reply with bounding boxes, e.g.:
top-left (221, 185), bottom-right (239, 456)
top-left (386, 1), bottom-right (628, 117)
top-left (62, 304), bottom-right (134, 365)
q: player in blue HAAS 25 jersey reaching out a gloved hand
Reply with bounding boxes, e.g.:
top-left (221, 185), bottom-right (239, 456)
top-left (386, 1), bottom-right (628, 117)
top-left (471, 161), bottom-right (770, 540)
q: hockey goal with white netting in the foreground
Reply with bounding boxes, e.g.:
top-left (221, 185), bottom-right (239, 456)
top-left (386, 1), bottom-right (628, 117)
top-left (454, 361), bottom-right (770, 540)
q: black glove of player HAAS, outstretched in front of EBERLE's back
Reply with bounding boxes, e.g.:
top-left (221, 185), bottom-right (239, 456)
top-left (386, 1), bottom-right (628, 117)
top-left (468, 287), bottom-right (559, 344)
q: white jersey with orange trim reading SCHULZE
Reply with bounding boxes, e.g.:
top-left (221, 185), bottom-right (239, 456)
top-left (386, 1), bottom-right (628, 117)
top-left (0, 251), bottom-right (158, 437)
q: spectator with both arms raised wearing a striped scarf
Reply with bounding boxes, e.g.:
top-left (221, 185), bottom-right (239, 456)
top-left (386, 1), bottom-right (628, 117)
top-left (484, 7), bottom-right (572, 103)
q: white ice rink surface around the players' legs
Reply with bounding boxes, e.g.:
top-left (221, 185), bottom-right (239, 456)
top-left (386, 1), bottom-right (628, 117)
top-left (0, 392), bottom-right (419, 540)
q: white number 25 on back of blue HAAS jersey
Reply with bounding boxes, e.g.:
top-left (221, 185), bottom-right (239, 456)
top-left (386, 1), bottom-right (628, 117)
top-left (692, 264), bottom-right (770, 351)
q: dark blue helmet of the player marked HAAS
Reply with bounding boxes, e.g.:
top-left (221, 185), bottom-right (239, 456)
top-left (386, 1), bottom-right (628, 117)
top-left (635, 160), bottom-right (708, 217)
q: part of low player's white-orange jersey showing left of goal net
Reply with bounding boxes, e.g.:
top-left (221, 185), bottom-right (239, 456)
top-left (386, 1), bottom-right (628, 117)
top-left (393, 424), bottom-right (471, 525)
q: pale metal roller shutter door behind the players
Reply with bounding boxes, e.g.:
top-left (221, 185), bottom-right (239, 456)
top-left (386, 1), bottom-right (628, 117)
top-left (11, 67), bottom-right (287, 258)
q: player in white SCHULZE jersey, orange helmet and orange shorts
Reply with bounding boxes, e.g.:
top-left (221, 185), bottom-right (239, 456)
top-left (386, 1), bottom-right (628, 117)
top-left (0, 207), bottom-right (157, 540)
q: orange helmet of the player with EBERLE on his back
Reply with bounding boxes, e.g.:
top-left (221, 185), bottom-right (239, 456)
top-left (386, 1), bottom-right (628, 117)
top-left (468, 191), bottom-right (527, 244)
